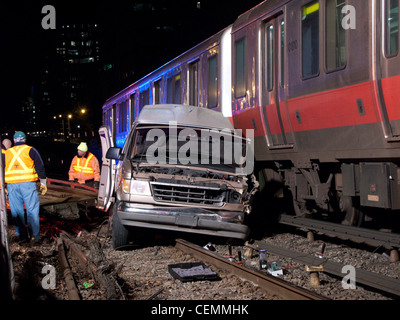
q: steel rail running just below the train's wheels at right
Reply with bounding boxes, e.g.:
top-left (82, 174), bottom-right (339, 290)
top-left (279, 215), bottom-right (400, 249)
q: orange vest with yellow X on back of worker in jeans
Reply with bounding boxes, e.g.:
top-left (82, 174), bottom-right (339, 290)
top-left (5, 144), bottom-right (39, 183)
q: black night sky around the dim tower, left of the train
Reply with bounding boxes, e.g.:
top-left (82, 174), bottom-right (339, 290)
top-left (0, 0), bottom-right (261, 133)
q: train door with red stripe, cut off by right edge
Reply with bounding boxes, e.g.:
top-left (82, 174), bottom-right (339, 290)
top-left (376, 0), bottom-right (400, 141)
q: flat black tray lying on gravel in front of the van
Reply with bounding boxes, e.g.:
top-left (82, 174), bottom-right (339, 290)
top-left (168, 262), bottom-right (219, 282)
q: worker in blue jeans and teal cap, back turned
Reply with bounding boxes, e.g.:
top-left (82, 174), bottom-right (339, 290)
top-left (4, 131), bottom-right (47, 244)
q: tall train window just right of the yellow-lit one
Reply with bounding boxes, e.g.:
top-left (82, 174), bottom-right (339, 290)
top-left (326, 0), bottom-right (346, 71)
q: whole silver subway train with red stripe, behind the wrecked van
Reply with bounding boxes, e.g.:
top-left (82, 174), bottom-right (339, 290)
top-left (103, 0), bottom-right (400, 226)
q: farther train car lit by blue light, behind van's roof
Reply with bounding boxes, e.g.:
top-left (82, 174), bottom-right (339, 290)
top-left (103, 26), bottom-right (232, 147)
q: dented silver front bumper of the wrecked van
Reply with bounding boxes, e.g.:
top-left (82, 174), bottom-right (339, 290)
top-left (116, 202), bottom-right (250, 240)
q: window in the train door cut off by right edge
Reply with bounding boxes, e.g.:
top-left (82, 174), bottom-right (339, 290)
top-left (385, 0), bottom-right (399, 57)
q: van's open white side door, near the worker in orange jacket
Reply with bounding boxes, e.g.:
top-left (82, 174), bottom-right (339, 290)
top-left (97, 126), bottom-right (116, 211)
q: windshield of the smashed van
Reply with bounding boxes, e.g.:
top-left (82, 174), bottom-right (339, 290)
top-left (128, 126), bottom-right (246, 168)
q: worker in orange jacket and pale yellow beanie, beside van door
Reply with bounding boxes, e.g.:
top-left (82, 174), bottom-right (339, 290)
top-left (68, 142), bottom-right (100, 189)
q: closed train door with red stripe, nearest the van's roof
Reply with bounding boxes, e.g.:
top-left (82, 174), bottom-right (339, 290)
top-left (262, 13), bottom-right (293, 149)
